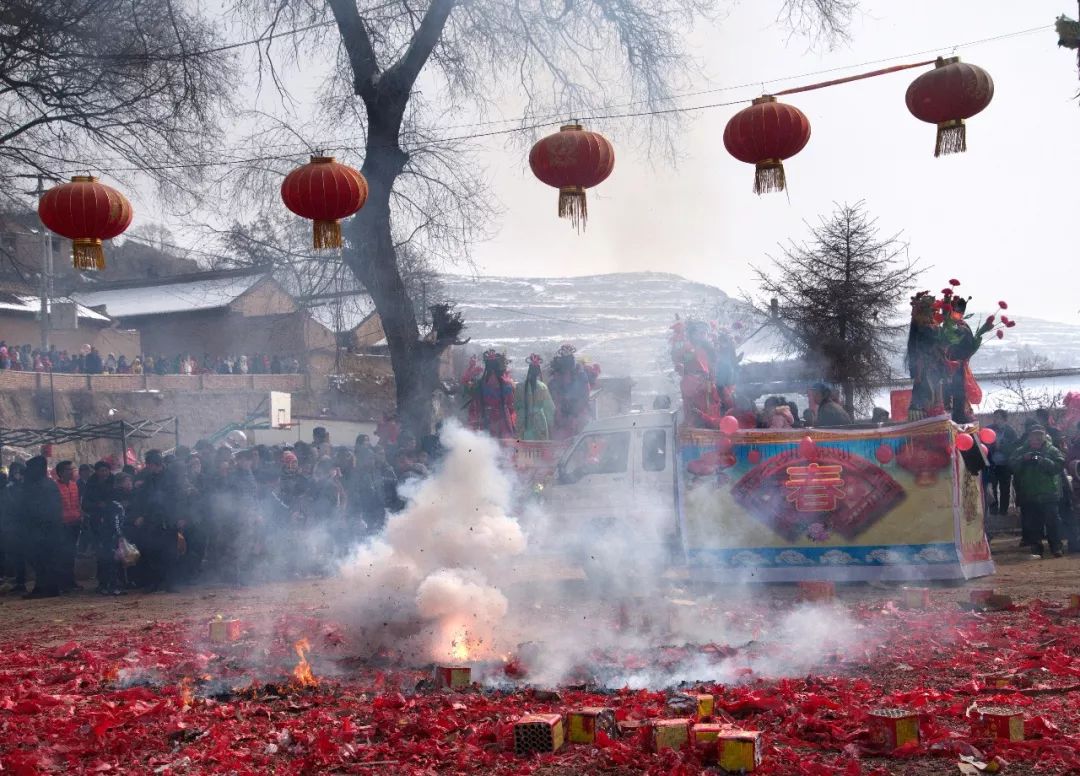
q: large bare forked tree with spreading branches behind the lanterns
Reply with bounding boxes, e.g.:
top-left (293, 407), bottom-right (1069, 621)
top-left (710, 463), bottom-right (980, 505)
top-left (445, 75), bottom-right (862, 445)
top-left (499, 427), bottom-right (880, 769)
top-left (239, 0), bottom-right (850, 433)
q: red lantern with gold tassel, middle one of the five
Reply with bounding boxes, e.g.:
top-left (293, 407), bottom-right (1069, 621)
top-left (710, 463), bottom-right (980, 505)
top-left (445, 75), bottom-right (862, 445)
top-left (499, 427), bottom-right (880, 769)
top-left (529, 124), bottom-right (615, 232)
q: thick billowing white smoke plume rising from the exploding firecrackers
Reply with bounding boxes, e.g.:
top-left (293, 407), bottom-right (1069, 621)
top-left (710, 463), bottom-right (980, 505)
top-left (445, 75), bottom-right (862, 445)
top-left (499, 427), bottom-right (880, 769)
top-left (336, 424), bottom-right (525, 661)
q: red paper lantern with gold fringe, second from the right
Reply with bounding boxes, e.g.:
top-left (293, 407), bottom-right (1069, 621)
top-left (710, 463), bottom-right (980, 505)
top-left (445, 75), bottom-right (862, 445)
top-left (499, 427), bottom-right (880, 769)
top-left (724, 95), bottom-right (810, 194)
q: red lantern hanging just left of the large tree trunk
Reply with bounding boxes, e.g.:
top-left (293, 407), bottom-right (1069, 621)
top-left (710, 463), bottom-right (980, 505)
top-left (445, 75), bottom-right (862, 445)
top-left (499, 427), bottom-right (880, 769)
top-left (281, 156), bottom-right (367, 250)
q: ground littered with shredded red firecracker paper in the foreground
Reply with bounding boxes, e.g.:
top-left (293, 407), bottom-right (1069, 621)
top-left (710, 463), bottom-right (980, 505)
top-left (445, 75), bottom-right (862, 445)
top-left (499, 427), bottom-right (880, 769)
top-left (0, 539), bottom-right (1080, 776)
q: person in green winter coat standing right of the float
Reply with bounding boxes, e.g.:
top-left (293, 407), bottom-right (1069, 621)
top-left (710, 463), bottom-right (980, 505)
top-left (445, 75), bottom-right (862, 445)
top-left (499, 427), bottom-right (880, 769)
top-left (1009, 425), bottom-right (1065, 558)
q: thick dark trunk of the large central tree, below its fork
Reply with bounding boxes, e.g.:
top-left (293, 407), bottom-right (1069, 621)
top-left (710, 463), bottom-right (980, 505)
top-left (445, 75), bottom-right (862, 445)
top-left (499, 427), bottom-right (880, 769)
top-left (345, 143), bottom-right (440, 439)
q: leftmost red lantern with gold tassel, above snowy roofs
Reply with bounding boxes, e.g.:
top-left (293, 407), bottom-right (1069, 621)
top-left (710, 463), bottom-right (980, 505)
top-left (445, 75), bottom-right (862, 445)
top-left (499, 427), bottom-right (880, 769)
top-left (38, 175), bottom-right (135, 270)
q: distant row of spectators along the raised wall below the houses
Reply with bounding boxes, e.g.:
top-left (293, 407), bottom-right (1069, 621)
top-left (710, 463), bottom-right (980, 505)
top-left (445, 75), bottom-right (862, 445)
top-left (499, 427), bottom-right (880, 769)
top-left (0, 340), bottom-right (301, 375)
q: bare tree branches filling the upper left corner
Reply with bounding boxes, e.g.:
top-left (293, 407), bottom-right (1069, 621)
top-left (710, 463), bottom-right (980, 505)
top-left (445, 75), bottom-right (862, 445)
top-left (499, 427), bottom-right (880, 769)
top-left (0, 0), bottom-right (234, 206)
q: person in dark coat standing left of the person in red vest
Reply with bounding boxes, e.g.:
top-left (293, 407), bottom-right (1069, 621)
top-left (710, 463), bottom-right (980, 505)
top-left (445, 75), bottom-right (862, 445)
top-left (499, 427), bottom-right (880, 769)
top-left (18, 455), bottom-right (64, 598)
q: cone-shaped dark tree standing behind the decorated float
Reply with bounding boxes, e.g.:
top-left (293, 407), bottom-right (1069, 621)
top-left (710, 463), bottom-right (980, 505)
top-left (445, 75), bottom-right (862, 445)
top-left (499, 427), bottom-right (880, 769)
top-left (747, 202), bottom-right (921, 413)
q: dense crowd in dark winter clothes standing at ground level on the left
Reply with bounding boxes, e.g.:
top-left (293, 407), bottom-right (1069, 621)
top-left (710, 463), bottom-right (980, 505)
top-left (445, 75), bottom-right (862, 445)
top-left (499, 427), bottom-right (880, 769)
top-left (0, 418), bottom-right (432, 598)
